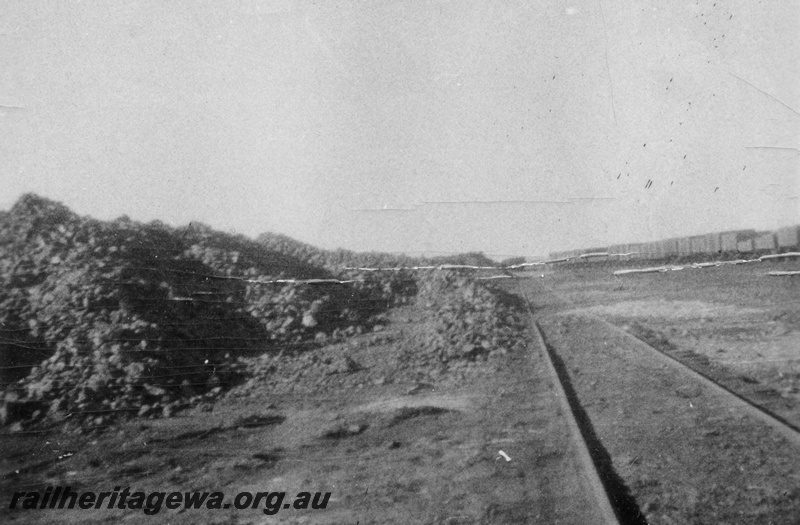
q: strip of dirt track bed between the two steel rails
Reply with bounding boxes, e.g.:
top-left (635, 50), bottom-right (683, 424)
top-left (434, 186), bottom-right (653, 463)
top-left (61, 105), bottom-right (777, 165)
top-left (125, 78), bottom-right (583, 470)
top-left (538, 314), bottom-right (800, 524)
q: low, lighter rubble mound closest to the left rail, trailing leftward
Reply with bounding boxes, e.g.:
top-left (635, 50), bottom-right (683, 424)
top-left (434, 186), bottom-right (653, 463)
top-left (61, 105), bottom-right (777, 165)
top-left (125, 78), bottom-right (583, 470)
top-left (228, 271), bottom-right (526, 396)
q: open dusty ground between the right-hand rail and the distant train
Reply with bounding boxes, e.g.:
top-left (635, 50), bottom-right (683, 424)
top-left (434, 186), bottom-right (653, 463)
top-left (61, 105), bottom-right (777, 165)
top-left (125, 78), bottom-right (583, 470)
top-left (554, 263), bottom-right (800, 428)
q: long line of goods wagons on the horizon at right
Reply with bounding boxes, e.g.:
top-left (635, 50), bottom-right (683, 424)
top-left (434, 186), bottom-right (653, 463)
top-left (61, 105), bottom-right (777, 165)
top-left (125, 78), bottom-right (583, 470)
top-left (550, 225), bottom-right (800, 262)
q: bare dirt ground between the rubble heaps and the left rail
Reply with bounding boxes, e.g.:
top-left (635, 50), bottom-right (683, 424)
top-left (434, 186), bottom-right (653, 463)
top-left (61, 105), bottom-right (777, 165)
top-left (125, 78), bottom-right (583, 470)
top-left (0, 300), bottom-right (608, 525)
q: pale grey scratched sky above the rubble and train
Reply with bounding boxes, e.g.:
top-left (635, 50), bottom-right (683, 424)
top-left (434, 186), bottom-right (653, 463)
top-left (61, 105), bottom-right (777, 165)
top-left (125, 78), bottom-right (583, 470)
top-left (0, 0), bottom-right (800, 257)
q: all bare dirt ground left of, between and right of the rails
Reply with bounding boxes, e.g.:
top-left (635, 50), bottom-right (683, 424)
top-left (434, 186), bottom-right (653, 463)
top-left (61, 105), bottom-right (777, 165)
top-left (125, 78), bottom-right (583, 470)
top-left (0, 262), bottom-right (800, 525)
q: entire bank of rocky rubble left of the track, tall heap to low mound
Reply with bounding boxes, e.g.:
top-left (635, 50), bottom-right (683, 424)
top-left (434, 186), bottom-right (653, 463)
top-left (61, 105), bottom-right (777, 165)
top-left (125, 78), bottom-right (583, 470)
top-left (0, 195), bottom-right (520, 429)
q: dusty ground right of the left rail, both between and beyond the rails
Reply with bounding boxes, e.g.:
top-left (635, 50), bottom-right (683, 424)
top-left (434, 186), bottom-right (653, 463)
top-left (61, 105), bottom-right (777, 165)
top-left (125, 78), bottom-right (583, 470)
top-left (512, 263), bottom-right (800, 523)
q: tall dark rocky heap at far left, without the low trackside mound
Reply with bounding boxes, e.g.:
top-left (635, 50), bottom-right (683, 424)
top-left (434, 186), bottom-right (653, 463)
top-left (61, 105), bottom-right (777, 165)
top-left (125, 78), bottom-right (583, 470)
top-left (0, 194), bottom-right (410, 428)
